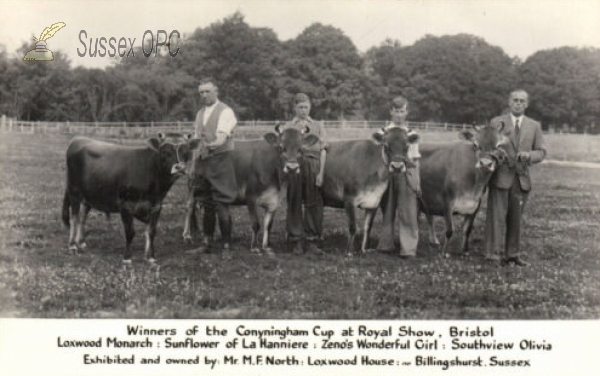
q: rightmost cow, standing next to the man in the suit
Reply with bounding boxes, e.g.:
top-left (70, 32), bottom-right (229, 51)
top-left (419, 124), bottom-right (509, 256)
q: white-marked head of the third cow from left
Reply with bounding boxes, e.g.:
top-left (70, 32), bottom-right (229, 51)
top-left (373, 127), bottom-right (420, 173)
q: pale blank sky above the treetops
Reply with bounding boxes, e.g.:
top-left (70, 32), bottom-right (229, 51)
top-left (0, 0), bottom-right (600, 67)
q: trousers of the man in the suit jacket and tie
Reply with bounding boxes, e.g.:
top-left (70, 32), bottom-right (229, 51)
top-left (485, 174), bottom-right (529, 257)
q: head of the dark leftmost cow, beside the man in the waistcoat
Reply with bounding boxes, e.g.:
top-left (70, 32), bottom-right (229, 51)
top-left (148, 133), bottom-right (197, 176)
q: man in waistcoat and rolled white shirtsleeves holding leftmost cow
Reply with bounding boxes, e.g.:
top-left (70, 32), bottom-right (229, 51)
top-left (187, 78), bottom-right (238, 255)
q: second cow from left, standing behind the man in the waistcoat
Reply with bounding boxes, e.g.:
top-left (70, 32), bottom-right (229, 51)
top-left (183, 124), bottom-right (319, 256)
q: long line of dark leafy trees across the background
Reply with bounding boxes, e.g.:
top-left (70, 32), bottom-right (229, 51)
top-left (0, 12), bottom-right (600, 133)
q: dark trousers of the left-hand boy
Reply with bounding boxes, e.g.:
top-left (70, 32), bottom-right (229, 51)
top-left (286, 157), bottom-right (323, 242)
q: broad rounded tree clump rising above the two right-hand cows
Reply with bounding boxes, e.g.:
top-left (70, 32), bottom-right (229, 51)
top-left (370, 34), bottom-right (516, 123)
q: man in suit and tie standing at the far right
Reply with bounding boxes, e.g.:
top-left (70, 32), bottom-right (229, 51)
top-left (485, 89), bottom-right (546, 266)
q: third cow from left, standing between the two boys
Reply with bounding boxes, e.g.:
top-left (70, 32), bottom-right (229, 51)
top-left (321, 128), bottom-right (419, 256)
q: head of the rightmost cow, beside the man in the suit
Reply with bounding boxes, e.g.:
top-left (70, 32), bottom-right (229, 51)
top-left (459, 122), bottom-right (510, 173)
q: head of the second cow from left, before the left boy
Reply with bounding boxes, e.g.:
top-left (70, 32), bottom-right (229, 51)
top-left (264, 124), bottom-right (319, 174)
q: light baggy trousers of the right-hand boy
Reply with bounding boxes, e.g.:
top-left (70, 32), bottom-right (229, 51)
top-left (377, 168), bottom-right (420, 256)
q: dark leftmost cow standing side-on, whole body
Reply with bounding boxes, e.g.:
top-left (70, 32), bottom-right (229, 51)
top-left (62, 133), bottom-right (197, 265)
